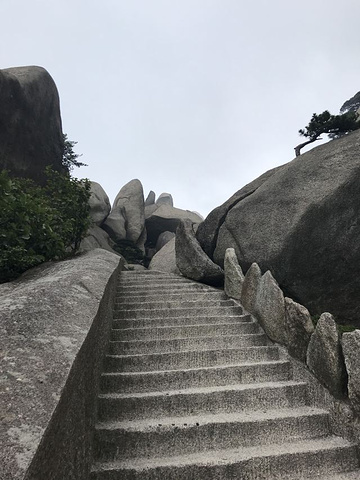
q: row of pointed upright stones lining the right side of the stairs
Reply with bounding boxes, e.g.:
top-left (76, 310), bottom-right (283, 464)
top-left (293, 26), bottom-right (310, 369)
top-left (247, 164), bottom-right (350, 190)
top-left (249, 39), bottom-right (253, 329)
top-left (224, 248), bottom-right (360, 413)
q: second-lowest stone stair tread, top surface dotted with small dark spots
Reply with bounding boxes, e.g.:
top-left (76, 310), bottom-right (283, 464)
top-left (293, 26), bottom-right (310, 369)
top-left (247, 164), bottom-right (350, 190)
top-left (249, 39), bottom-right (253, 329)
top-left (96, 406), bottom-right (329, 431)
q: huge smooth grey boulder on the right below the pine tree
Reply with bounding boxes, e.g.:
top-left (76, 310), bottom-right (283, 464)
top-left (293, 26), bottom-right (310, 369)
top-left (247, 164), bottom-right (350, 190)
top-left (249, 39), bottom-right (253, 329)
top-left (197, 131), bottom-right (360, 324)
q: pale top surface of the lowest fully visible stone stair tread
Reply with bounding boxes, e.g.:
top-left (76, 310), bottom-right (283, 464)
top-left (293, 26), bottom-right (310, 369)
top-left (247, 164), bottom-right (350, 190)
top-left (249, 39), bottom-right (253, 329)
top-left (93, 436), bottom-right (355, 471)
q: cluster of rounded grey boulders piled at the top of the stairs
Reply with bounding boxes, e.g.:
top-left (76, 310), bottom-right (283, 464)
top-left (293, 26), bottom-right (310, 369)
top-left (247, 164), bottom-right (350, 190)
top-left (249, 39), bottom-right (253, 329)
top-left (81, 179), bottom-right (212, 278)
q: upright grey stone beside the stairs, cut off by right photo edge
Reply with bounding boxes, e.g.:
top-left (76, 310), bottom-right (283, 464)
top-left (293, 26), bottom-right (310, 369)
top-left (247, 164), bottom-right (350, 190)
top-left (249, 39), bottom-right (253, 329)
top-left (342, 330), bottom-right (360, 414)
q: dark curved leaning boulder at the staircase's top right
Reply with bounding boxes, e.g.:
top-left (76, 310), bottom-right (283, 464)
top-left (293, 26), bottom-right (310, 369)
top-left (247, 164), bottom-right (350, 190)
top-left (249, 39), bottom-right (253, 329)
top-left (175, 219), bottom-right (224, 285)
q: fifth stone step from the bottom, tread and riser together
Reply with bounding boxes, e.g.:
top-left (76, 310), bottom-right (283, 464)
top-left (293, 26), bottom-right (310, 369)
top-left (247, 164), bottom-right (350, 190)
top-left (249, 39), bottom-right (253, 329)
top-left (104, 342), bottom-right (279, 372)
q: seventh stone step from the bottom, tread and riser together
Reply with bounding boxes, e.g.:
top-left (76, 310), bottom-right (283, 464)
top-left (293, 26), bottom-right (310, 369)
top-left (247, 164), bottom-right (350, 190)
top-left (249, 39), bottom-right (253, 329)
top-left (110, 317), bottom-right (261, 341)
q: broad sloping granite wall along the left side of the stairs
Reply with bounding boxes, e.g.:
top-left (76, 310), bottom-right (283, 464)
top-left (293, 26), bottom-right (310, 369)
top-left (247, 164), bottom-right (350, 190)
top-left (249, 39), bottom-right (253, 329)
top-left (0, 249), bottom-right (120, 480)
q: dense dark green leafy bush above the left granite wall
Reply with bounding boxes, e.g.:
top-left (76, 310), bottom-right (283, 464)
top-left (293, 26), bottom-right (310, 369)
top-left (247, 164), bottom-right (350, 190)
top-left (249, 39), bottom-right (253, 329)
top-left (0, 169), bottom-right (90, 283)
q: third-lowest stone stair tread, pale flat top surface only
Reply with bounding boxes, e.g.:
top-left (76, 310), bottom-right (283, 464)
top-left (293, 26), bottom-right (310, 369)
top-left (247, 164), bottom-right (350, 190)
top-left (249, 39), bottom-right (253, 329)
top-left (99, 380), bottom-right (306, 399)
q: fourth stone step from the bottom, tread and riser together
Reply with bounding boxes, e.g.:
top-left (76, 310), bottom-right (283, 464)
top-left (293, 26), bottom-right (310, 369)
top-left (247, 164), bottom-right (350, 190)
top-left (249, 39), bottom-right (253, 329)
top-left (101, 360), bottom-right (291, 393)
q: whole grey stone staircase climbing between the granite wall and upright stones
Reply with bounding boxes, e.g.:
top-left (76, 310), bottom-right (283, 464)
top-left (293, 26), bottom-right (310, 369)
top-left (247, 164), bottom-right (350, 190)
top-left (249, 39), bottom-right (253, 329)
top-left (90, 271), bottom-right (360, 480)
